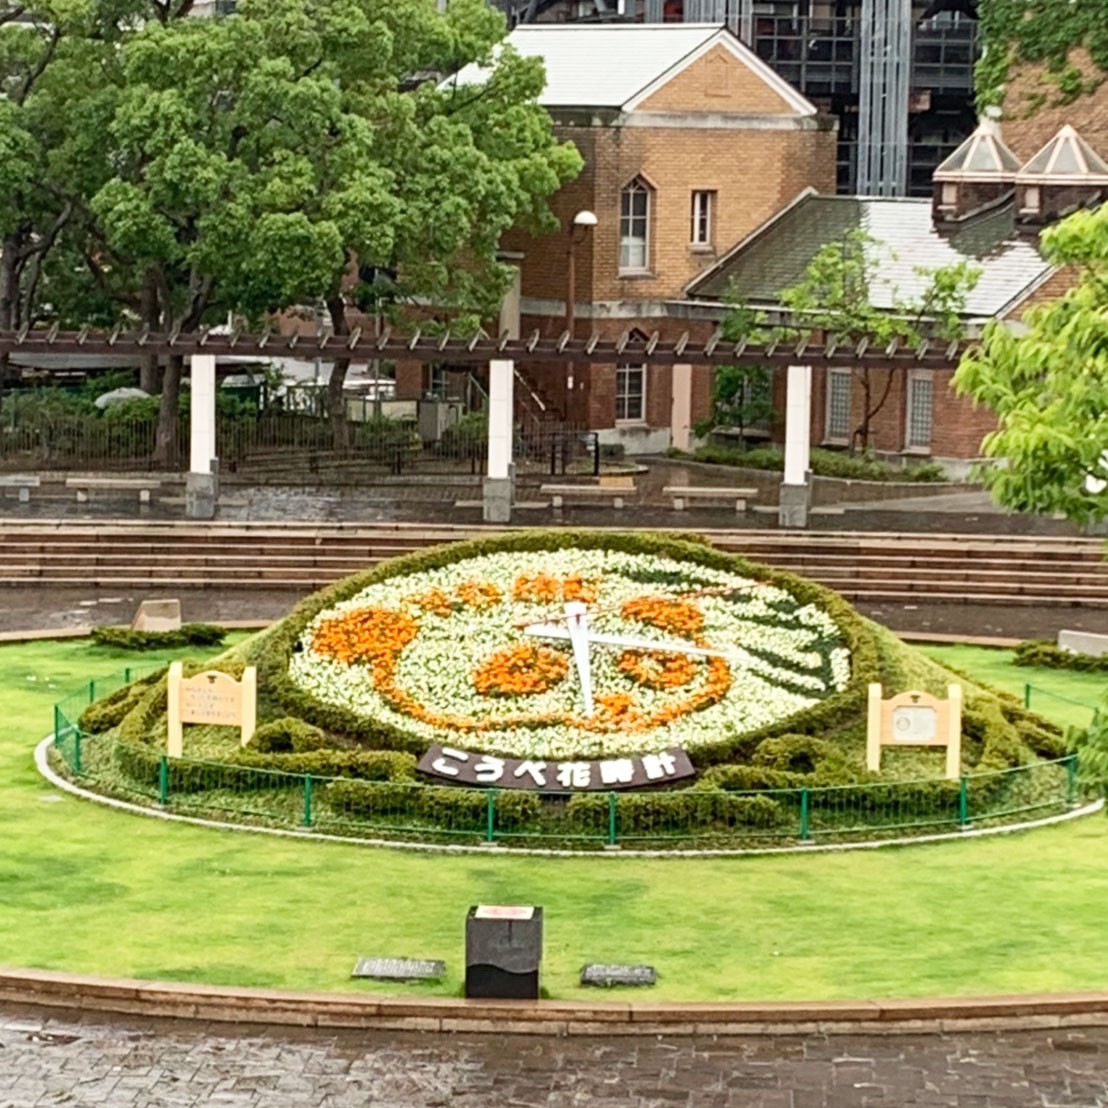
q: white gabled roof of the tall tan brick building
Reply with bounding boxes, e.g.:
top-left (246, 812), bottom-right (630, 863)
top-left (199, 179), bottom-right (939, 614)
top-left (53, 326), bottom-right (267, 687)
top-left (449, 23), bottom-right (817, 115)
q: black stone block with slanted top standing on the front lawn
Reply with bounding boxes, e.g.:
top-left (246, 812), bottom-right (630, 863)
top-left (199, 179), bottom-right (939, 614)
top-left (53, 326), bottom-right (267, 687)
top-left (465, 904), bottom-right (543, 1001)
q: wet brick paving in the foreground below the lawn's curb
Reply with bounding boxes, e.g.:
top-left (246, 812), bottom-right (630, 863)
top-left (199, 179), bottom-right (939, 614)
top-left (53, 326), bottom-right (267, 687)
top-left (0, 1007), bottom-right (1108, 1108)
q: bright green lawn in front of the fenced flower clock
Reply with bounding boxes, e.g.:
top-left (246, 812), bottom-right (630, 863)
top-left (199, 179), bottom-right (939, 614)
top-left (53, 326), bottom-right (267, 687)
top-left (0, 640), bottom-right (1108, 999)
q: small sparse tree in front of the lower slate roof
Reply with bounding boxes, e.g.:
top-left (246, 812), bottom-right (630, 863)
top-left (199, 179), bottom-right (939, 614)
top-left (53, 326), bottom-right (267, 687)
top-left (725, 228), bottom-right (981, 451)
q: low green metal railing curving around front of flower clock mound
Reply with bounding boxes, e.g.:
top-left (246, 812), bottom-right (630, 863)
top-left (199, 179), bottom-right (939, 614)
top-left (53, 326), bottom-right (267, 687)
top-left (53, 667), bottom-right (1078, 850)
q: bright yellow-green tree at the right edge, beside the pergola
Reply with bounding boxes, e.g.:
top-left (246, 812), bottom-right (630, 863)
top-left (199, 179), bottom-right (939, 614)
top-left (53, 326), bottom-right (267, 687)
top-left (954, 204), bottom-right (1108, 524)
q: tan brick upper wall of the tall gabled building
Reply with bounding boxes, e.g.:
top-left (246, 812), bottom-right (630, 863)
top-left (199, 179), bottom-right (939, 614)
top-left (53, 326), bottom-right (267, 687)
top-left (504, 47), bottom-right (835, 314)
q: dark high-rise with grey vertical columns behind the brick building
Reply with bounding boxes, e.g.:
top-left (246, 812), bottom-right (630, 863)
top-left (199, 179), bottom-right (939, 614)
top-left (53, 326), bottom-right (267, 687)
top-left (490, 0), bottom-right (977, 196)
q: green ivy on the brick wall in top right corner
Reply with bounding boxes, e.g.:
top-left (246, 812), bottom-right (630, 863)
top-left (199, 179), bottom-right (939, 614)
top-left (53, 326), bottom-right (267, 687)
top-left (974, 0), bottom-right (1108, 115)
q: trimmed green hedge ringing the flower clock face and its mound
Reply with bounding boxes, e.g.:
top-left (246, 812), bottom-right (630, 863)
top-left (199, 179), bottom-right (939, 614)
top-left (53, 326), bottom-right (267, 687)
top-left (71, 522), bottom-right (1064, 838)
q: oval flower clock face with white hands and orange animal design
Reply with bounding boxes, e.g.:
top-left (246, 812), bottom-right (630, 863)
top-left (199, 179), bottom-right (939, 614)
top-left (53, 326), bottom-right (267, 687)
top-left (289, 548), bottom-right (850, 759)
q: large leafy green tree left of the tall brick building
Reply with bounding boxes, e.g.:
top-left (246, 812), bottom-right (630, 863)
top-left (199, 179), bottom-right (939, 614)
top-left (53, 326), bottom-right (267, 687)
top-left (40, 0), bottom-right (581, 463)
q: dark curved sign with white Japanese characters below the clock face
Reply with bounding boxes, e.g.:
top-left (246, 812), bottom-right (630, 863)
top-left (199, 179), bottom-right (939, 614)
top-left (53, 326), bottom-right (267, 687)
top-left (419, 743), bottom-right (696, 792)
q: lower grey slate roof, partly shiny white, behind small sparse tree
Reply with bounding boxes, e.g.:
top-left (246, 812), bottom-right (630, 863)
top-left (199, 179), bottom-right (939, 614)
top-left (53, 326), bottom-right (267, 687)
top-left (686, 192), bottom-right (1053, 319)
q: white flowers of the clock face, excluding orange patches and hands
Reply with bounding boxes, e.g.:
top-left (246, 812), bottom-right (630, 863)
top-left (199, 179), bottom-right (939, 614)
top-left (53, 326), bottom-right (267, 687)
top-left (289, 550), bottom-right (850, 758)
